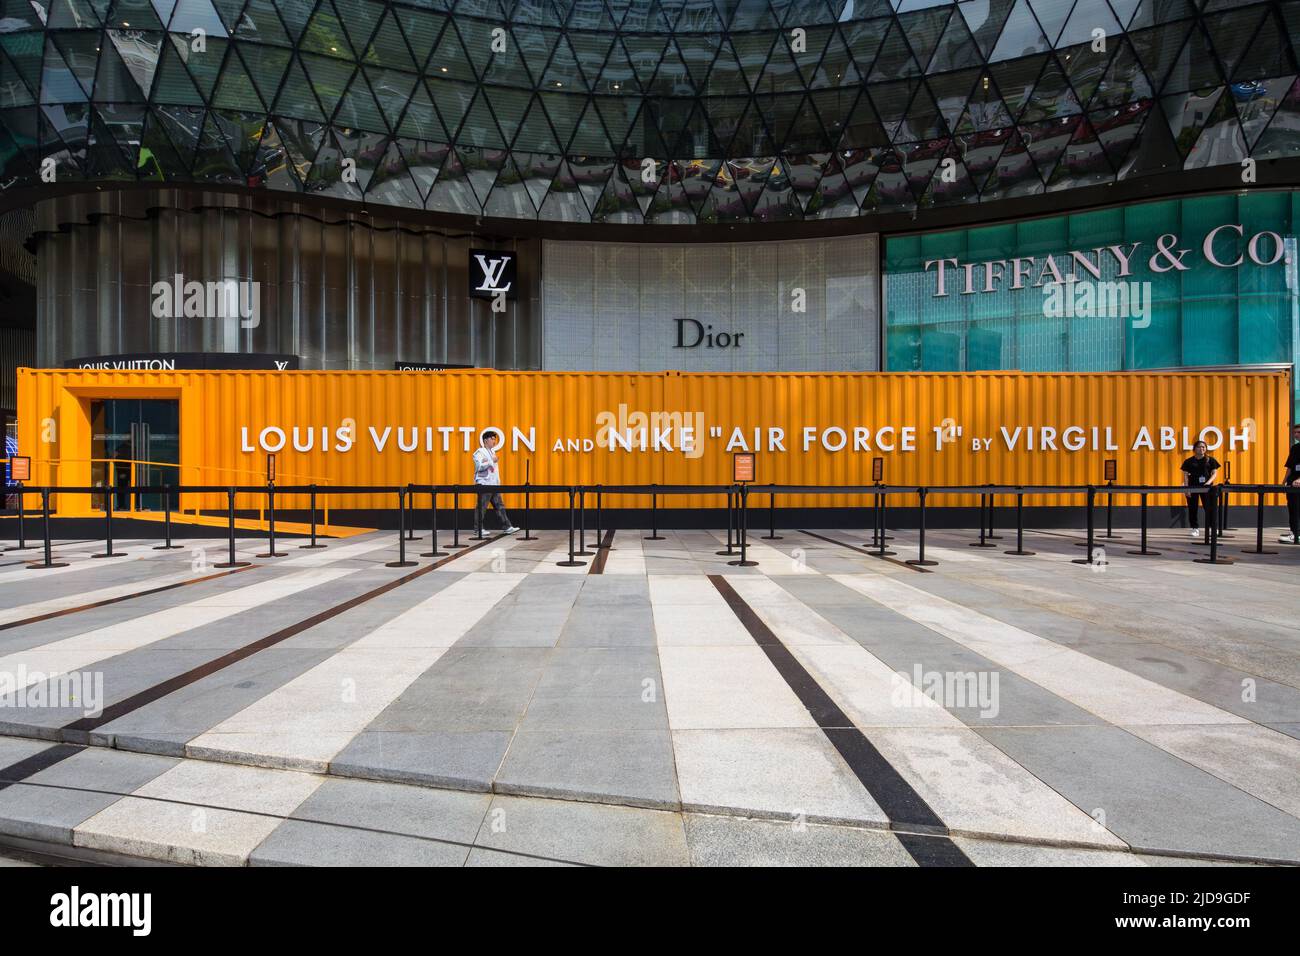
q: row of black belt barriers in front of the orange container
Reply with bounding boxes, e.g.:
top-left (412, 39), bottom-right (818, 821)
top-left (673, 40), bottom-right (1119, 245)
top-left (7, 483), bottom-right (1300, 568)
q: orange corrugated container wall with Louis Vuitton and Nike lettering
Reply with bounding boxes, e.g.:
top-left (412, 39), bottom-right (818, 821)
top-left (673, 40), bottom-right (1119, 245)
top-left (18, 369), bottom-right (1290, 507)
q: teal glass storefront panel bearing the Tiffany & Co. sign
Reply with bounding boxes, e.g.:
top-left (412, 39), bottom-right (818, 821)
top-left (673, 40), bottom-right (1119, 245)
top-left (884, 191), bottom-right (1300, 420)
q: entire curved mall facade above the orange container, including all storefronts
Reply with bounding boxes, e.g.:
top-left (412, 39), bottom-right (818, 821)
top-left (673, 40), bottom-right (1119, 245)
top-left (0, 0), bottom-right (1300, 418)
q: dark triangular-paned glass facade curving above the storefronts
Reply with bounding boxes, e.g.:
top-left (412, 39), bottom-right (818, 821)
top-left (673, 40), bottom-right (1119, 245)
top-left (0, 0), bottom-right (1300, 225)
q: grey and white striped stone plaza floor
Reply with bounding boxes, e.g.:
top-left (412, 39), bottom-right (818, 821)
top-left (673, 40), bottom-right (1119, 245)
top-left (0, 529), bottom-right (1300, 866)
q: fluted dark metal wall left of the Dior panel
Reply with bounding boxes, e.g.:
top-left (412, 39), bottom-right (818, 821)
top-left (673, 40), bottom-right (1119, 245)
top-left (35, 190), bottom-right (541, 369)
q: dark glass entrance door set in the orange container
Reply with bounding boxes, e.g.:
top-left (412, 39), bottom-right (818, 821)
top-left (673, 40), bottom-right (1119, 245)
top-left (91, 398), bottom-right (181, 511)
